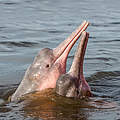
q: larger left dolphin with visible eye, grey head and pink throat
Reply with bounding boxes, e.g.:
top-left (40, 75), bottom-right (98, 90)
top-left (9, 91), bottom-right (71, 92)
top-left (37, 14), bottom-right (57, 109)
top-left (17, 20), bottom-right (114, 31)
top-left (11, 21), bottom-right (89, 101)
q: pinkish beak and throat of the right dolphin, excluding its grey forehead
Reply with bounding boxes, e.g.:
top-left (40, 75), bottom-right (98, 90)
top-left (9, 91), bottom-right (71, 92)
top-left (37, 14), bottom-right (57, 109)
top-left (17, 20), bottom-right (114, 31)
top-left (69, 32), bottom-right (92, 97)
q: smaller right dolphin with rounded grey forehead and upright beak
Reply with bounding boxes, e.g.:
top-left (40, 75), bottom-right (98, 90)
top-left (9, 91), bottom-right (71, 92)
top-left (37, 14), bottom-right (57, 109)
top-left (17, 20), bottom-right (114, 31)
top-left (56, 31), bottom-right (92, 98)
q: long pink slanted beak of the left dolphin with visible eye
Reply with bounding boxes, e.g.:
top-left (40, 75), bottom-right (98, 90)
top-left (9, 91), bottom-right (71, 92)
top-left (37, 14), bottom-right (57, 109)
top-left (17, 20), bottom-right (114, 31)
top-left (53, 21), bottom-right (89, 72)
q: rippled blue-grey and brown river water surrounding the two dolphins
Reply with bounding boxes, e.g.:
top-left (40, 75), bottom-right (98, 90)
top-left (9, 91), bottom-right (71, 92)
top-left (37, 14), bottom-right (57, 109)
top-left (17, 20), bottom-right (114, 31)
top-left (0, 0), bottom-right (120, 120)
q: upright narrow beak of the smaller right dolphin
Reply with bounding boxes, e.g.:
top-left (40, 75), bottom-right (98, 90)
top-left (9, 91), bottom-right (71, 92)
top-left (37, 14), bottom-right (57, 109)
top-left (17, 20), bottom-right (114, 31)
top-left (69, 31), bottom-right (89, 79)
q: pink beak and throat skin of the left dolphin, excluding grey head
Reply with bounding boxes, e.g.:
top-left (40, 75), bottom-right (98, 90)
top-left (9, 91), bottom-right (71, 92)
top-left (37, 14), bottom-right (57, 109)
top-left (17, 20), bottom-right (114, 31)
top-left (37, 23), bottom-right (89, 91)
